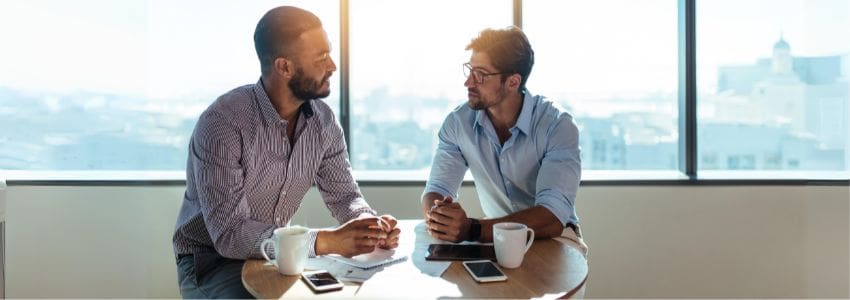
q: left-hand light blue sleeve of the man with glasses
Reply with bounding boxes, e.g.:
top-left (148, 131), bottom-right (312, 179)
top-left (422, 114), bottom-right (469, 199)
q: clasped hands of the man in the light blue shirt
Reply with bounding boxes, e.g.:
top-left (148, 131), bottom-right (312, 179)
top-left (426, 197), bottom-right (470, 242)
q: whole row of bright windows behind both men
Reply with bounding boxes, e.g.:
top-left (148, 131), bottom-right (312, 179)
top-left (0, 0), bottom-right (850, 180)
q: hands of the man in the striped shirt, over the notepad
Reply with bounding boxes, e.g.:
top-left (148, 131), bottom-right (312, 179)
top-left (316, 217), bottom-right (388, 257)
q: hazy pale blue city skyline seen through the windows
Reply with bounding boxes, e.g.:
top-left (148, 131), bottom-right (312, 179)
top-left (0, 38), bottom-right (848, 170)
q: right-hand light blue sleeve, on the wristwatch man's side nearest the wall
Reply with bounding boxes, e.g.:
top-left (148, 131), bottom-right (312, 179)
top-left (535, 115), bottom-right (581, 226)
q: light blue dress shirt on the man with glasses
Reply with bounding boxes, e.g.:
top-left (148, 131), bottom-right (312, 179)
top-left (425, 90), bottom-right (581, 226)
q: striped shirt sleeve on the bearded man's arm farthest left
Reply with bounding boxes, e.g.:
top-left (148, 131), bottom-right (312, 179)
top-left (189, 111), bottom-right (275, 259)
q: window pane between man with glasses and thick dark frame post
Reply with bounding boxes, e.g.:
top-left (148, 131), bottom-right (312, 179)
top-left (523, 0), bottom-right (679, 170)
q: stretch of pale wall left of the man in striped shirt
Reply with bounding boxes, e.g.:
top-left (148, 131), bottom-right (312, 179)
top-left (6, 186), bottom-right (182, 298)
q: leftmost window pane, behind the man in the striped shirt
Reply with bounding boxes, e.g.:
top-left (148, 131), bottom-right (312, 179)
top-left (0, 0), bottom-right (339, 170)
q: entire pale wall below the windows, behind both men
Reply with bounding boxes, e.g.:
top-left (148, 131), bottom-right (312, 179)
top-left (1, 185), bottom-right (850, 298)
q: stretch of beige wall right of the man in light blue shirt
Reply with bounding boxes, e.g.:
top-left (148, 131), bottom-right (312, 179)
top-left (579, 186), bottom-right (850, 298)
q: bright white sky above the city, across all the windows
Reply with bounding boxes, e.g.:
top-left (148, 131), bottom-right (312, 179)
top-left (0, 0), bottom-right (850, 101)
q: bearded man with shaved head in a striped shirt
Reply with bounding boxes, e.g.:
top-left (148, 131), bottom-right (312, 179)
top-left (173, 6), bottom-right (399, 298)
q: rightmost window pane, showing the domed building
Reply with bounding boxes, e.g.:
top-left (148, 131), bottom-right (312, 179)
top-left (697, 0), bottom-right (850, 171)
